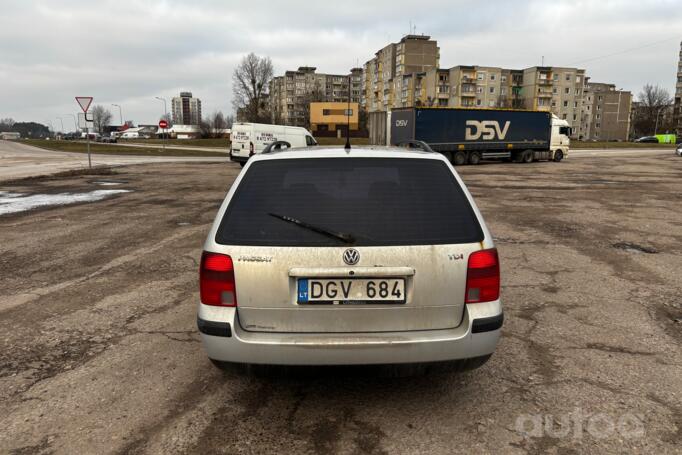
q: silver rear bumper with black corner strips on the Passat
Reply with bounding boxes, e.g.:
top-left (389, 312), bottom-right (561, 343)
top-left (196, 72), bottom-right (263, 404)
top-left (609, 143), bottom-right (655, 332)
top-left (198, 300), bottom-right (503, 365)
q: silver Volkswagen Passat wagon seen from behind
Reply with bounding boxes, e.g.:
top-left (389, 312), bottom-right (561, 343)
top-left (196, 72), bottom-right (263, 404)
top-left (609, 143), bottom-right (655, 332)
top-left (198, 148), bottom-right (503, 368)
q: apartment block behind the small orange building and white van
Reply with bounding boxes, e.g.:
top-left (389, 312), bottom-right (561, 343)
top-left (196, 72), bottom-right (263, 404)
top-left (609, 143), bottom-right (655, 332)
top-left (270, 66), bottom-right (362, 127)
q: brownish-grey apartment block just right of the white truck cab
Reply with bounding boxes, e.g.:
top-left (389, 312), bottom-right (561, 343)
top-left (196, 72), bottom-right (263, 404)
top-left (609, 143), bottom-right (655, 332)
top-left (573, 77), bottom-right (632, 141)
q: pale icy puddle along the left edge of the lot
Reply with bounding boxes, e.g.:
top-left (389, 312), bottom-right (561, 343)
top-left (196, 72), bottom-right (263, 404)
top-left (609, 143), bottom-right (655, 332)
top-left (0, 190), bottom-right (130, 215)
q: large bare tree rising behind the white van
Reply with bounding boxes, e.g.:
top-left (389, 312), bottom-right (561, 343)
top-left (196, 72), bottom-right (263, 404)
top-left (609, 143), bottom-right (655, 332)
top-left (232, 52), bottom-right (273, 122)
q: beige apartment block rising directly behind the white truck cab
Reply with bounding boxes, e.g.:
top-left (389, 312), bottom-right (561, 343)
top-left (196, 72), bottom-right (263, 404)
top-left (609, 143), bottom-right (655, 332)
top-left (521, 66), bottom-right (585, 137)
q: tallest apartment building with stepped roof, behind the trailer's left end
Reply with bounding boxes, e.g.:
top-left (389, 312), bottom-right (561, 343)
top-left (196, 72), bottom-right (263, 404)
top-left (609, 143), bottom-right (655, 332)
top-left (362, 35), bottom-right (440, 112)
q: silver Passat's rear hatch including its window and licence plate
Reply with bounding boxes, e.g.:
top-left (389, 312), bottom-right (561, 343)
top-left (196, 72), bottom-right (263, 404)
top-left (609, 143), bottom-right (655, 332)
top-left (216, 157), bottom-right (483, 333)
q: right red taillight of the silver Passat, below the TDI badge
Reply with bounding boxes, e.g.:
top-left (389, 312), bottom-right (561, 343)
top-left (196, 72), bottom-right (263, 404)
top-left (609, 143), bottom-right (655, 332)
top-left (464, 248), bottom-right (500, 303)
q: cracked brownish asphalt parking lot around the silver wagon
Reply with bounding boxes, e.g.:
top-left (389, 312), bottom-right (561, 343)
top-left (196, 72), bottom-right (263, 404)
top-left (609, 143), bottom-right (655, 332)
top-left (0, 152), bottom-right (682, 454)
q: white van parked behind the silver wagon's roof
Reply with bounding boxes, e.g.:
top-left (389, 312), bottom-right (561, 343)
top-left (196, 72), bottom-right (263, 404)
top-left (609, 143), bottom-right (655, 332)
top-left (230, 122), bottom-right (317, 166)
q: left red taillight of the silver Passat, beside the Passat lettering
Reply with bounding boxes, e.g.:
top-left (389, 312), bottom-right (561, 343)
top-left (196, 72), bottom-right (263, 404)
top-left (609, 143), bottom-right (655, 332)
top-left (199, 251), bottom-right (237, 306)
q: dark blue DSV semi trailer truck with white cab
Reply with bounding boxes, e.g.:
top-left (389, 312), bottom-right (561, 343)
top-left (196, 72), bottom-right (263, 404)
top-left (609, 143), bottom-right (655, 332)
top-left (386, 108), bottom-right (571, 165)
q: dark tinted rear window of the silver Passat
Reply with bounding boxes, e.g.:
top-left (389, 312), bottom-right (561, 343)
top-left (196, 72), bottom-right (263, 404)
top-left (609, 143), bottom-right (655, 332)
top-left (216, 158), bottom-right (483, 246)
